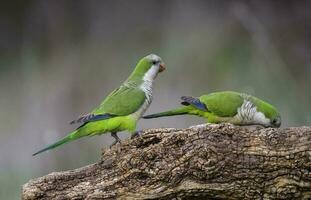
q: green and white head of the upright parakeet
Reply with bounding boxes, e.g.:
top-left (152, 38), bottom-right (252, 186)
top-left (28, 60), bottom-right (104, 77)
top-left (131, 54), bottom-right (165, 81)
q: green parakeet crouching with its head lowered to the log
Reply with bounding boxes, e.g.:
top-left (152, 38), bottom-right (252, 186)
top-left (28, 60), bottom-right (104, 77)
top-left (143, 91), bottom-right (281, 127)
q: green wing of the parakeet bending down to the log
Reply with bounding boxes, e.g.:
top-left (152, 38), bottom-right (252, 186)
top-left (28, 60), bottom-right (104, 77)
top-left (200, 91), bottom-right (244, 117)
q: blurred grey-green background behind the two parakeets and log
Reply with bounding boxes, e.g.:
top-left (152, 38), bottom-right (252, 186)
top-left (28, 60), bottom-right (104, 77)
top-left (0, 0), bottom-right (311, 199)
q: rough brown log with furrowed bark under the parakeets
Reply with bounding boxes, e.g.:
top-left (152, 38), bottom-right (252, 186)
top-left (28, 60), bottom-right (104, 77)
top-left (22, 124), bottom-right (311, 200)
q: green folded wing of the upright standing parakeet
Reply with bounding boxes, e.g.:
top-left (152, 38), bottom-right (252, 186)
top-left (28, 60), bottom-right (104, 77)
top-left (92, 85), bottom-right (146, 116)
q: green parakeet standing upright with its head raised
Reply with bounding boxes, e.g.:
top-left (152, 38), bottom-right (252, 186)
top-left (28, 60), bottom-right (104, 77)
top-left (33, 54), bottom-right (165, 155)
